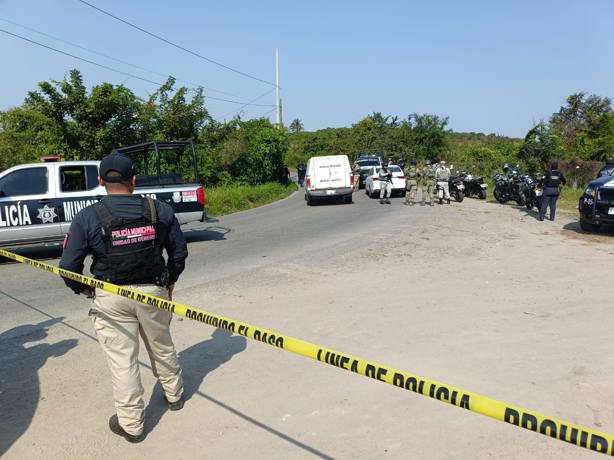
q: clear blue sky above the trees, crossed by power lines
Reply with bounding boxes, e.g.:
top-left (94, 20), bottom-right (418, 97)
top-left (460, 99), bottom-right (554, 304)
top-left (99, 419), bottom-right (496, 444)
top-left (0, 0), bottom-right (614, 137)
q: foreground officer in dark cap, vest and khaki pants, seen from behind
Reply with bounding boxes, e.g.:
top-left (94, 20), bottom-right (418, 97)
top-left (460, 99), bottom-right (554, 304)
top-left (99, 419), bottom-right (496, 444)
top-left (60, 153), bottom-right (188, 443)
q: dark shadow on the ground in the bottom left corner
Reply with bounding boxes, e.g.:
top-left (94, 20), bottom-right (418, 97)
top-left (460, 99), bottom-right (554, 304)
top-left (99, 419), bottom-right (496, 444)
top-left (0, 317), bottom-right (78, 456)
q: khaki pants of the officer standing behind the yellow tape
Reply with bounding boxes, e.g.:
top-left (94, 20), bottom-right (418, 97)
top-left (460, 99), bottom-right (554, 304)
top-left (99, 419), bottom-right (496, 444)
top-left (90, 284), bottom-right (183, 435)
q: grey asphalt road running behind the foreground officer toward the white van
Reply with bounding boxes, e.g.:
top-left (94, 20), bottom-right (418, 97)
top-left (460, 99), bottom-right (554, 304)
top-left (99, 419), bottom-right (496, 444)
top-left (0, 189), bottom-right (414, 332)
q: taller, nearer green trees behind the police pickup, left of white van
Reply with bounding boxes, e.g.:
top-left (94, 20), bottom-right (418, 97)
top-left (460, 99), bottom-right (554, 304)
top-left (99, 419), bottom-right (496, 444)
top-left (0, 70), bottom-right (287, 185)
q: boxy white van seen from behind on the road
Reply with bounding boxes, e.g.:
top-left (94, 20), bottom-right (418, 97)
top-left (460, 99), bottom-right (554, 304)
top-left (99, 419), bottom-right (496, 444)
top-left (305, 155), bottom-right (354, 205)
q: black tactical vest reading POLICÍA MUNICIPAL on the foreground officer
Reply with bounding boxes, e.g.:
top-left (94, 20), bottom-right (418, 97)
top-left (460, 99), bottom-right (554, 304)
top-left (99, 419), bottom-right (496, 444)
top-left (93, 197), bottom-right (165, 285)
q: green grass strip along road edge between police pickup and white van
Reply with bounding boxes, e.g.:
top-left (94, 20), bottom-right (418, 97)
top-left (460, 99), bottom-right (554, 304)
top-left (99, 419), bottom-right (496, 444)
top-left (205, 182), bottom-right (297, 216)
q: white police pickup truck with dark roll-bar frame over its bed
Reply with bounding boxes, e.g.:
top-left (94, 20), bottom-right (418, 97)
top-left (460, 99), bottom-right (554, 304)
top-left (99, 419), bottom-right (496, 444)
top-left (0, 142), bottom-right (205, 246)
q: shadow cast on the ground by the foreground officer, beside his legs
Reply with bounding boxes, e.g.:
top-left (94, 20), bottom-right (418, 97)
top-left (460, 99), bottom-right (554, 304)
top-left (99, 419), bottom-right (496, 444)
top-left (145, 329), bottom-right (247, 433)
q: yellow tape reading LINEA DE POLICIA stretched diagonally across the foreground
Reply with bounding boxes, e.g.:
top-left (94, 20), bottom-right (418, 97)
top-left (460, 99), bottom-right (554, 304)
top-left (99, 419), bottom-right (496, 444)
top-left (0, 249), bottom-right (614, 456)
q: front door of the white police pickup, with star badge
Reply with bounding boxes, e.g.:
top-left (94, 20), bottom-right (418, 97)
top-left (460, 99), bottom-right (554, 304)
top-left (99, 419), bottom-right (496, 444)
top-left (0, 164), bottom-right (62, 244)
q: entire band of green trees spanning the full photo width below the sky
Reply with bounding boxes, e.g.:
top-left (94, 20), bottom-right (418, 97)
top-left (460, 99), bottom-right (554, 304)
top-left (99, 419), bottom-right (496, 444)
top-left (0, 70), bottom-right (614, 186)
